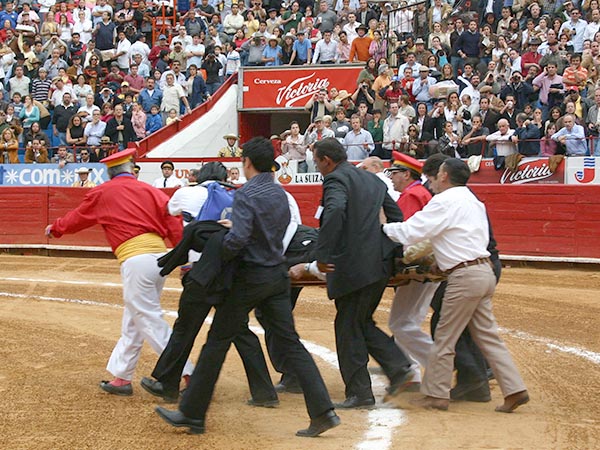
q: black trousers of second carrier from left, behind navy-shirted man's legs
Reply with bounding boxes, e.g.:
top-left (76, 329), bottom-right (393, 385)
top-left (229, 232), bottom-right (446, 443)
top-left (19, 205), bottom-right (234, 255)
top-left (152, 277), bottom-right (277, 400)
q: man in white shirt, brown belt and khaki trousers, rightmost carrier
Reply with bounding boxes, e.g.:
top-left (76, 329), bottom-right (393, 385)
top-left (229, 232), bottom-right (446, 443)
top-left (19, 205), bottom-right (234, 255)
top-left (383, 158), bottom-right (529, 413)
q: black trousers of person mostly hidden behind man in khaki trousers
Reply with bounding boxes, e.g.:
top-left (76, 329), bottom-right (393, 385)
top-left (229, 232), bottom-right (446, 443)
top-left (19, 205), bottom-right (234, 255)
top-left (431, 260), bottom-right (502, 384)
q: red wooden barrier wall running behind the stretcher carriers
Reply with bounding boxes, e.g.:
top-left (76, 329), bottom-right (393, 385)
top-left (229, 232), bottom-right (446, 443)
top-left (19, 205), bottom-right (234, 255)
top-left (0, 185), bottom-right (600, 258)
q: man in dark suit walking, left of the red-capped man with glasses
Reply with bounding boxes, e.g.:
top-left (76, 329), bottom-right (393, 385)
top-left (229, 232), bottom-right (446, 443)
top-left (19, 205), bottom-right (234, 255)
top-left (315, 138), bottom-right (414, 408)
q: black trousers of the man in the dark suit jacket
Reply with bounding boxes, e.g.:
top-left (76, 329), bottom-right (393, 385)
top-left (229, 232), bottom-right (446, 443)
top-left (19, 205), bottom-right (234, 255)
top-left (335, 277), bottom-right (410, 398)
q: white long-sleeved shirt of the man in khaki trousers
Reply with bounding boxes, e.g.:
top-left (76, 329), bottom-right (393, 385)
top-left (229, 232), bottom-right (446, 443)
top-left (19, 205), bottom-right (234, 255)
top-left (383, 186), bottom-right (490, 270)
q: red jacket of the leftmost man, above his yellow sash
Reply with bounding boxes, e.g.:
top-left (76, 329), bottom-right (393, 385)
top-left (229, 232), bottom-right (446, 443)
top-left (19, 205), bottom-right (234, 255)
top-left (52, 175), bottom-right (183, 251)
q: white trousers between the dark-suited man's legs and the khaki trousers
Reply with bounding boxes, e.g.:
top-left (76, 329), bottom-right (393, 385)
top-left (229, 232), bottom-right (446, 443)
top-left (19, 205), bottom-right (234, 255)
top-left (389, 280), bottom-right (440, 382)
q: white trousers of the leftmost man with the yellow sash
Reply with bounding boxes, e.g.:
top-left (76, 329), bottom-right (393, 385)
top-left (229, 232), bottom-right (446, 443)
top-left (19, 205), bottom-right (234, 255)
top-left (106, 253), bottom-right (194, 380)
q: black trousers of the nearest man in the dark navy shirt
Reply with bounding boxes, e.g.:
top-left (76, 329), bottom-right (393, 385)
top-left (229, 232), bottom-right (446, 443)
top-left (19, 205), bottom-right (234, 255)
top-left (179, 268), bottom-right (333, 419)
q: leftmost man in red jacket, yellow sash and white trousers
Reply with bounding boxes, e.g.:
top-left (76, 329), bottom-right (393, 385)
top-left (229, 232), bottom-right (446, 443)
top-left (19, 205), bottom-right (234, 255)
top-left (46, 149), bottom-right (193, 395)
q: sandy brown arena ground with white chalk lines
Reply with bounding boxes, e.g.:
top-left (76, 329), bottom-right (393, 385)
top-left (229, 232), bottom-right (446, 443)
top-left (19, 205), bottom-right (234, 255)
top-left (0, 255), bottom-right (600, 450)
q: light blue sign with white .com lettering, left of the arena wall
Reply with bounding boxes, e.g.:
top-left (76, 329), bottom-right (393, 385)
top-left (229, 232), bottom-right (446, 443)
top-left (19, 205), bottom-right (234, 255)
top-left (0, 163), bottom-right (108, 187)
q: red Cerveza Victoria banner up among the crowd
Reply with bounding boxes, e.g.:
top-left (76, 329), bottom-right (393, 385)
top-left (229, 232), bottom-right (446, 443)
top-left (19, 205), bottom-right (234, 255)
top-left (238, 65), bottom-right (364, 110)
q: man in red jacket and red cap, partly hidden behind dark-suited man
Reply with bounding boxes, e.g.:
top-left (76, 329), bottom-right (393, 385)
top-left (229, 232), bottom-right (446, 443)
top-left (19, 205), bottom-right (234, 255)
top-left (388, 152), bottom-right (440, 392)
